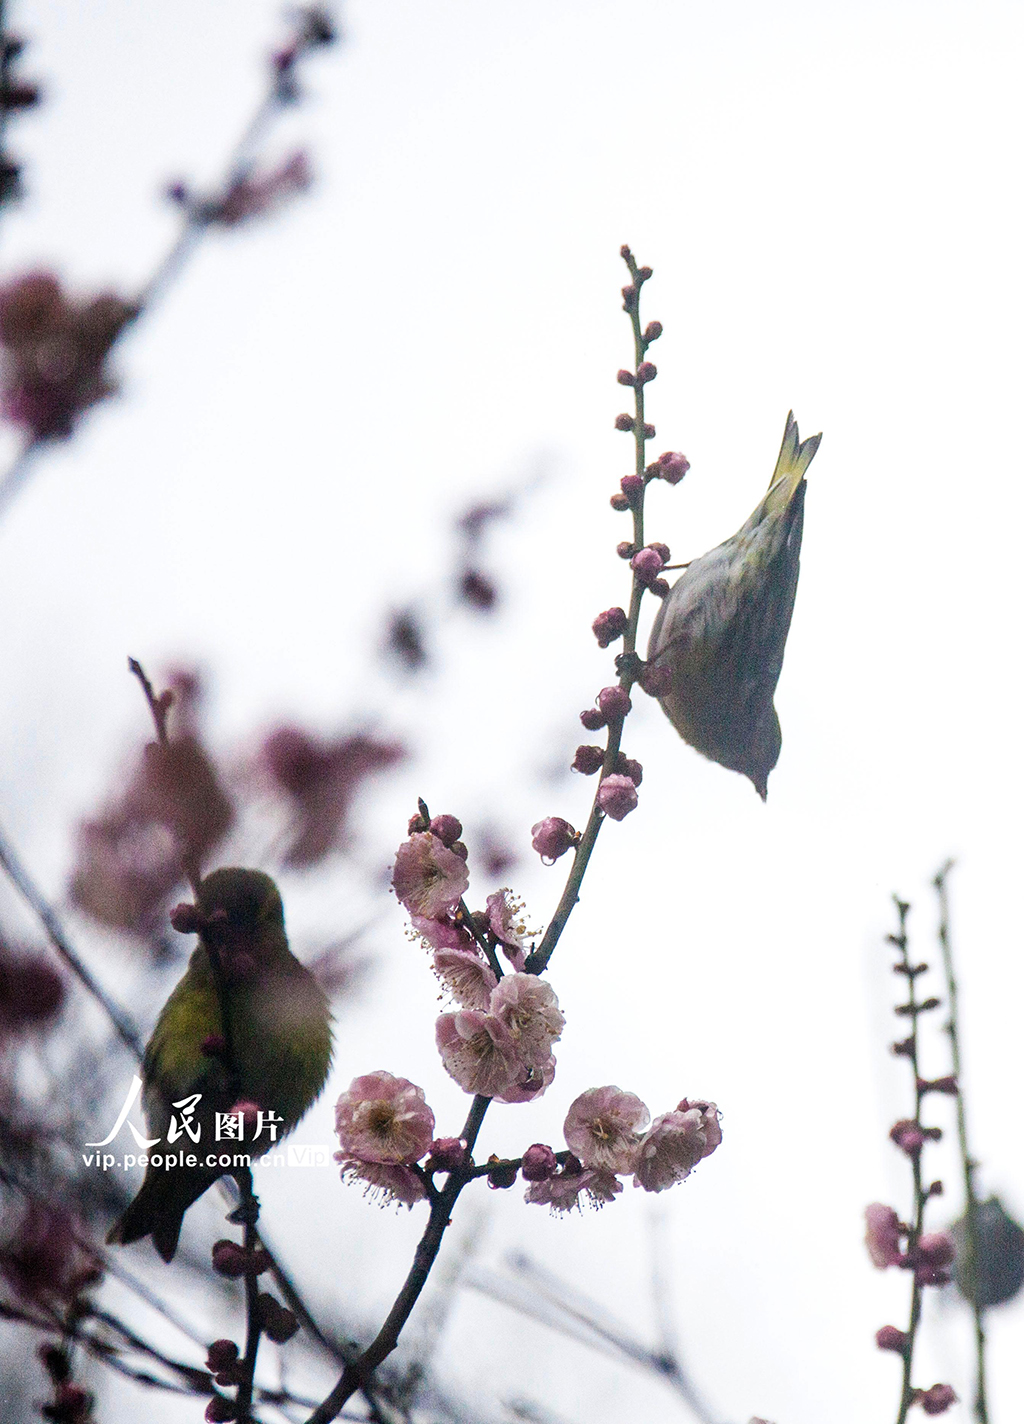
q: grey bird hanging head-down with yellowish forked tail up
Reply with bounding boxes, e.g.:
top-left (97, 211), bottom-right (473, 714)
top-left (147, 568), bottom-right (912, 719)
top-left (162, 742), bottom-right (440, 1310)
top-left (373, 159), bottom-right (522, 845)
top-left (647, 410), bottom-right (822, 800)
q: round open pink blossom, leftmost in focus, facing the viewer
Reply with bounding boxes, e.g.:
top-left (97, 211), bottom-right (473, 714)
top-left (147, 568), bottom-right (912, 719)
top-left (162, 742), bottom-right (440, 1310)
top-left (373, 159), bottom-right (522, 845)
top-left (335, 1069), bottom-right (434, 1163)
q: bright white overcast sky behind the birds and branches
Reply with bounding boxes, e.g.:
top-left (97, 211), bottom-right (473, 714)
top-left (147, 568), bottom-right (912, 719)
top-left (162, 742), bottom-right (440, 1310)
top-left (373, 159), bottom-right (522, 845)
top-left (0, 0), bottom-right (1024, 1424)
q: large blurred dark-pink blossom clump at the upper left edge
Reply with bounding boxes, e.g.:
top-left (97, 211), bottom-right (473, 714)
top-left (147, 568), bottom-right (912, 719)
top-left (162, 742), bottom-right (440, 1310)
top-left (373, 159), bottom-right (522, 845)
top-left (0, 272), bottom-right (138, 440)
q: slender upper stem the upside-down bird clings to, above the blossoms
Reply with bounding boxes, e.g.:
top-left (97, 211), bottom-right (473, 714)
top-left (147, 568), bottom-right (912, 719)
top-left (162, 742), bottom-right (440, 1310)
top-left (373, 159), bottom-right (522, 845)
top-left (526, 246), bottom-right (649, 974)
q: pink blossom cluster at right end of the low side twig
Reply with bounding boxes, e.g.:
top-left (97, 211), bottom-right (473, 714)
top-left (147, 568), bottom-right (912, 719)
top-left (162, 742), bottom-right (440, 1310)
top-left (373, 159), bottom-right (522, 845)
top-left (521, 1085), bottom-right (722, 1212)
